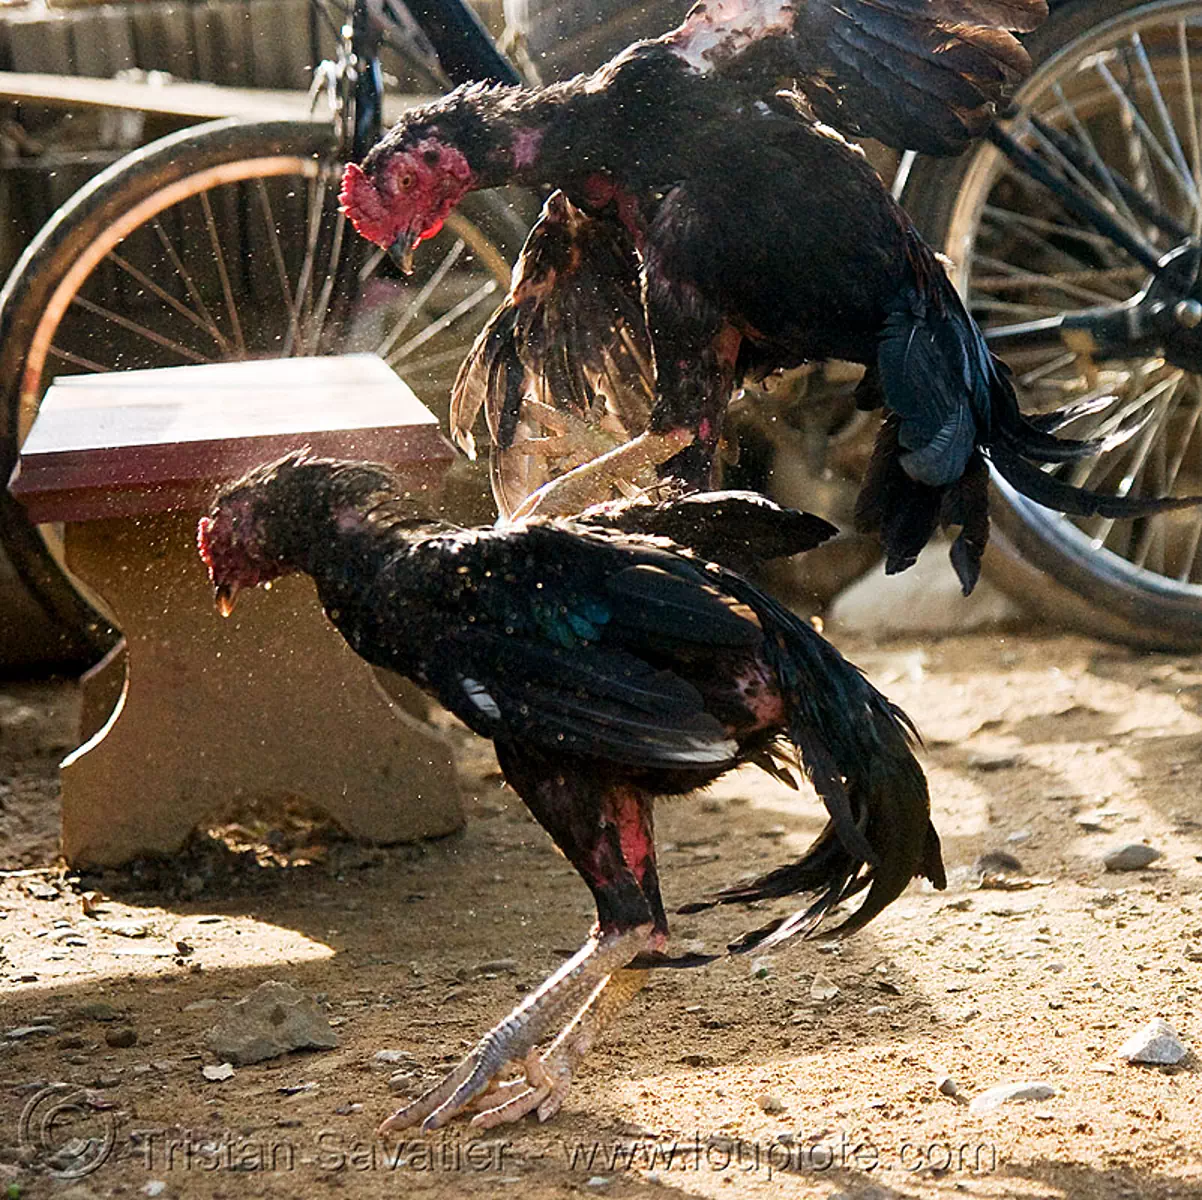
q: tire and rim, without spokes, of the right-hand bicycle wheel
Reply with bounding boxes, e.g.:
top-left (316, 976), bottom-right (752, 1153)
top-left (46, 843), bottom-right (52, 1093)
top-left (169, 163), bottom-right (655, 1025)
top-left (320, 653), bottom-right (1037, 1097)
top-left (903, 0), bottom-right (1202, 651)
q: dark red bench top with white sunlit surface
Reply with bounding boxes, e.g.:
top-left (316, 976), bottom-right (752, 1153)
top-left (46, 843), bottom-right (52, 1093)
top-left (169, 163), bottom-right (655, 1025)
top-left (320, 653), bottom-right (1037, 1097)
top-left (10, 354), bottom-right (453, 523)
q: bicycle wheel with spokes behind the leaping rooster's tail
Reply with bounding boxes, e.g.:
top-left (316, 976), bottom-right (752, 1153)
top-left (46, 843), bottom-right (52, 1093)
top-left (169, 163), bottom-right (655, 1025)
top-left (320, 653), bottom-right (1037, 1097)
top-left (904, 0), bottom-right (1202, 649)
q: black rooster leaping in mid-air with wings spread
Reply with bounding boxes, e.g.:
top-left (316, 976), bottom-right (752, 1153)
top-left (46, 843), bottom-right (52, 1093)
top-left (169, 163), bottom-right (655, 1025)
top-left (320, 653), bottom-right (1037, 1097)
top-left (343, 0), bottom-right (1190, 592)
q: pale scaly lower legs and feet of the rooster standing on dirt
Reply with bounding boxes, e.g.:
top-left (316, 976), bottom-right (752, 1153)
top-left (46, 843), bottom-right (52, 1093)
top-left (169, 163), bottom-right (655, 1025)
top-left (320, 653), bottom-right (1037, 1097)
top-left (379, 926), bottom-right (653, 1134)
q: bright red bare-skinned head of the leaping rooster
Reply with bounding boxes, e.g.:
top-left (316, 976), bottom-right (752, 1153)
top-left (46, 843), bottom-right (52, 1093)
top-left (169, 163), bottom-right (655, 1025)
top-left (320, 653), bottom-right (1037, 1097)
top-left (339, 131), bottom-right (475, 274)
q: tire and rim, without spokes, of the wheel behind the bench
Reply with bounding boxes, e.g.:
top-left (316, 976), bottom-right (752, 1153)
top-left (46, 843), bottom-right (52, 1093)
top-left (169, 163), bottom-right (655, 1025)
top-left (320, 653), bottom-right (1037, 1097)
top-left (0, 119), bottom-right (526, 665)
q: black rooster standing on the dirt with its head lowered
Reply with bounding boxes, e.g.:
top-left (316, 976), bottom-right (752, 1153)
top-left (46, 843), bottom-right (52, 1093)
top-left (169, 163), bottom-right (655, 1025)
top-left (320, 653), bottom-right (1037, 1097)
top-left (198, 455), bottom-right (945, 1129)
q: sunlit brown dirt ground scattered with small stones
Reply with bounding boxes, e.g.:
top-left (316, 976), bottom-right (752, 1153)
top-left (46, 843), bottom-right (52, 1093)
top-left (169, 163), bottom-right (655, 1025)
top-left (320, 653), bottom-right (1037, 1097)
top-left (0, 635), bottom-right (1202, 1200)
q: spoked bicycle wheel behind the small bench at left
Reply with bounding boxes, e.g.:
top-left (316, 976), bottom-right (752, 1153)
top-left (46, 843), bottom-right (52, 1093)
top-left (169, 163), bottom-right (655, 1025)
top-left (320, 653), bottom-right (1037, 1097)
top-left (0, 120), bottom-right (525, 661)
